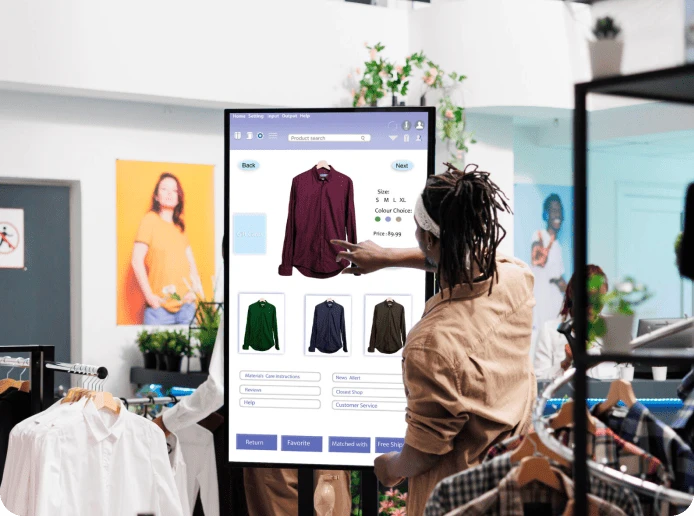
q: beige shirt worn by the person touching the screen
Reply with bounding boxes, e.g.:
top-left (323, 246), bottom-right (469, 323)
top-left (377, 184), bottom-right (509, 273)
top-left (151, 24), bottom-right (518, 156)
top-left (403, 256), bottom-right (537, 516)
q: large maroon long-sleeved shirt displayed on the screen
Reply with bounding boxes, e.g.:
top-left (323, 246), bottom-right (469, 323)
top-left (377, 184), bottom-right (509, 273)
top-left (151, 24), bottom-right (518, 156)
top-left (279, 167), bottom-right (357, 278)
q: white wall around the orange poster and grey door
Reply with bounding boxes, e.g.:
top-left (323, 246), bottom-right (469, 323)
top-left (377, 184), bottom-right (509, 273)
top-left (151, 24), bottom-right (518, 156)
top-left (0, 92), bottom-right (224, 395)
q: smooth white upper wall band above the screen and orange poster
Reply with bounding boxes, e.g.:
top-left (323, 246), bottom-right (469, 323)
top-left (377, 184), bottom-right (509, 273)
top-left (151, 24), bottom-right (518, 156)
top-left (0, 0), bottom-right (409, 107)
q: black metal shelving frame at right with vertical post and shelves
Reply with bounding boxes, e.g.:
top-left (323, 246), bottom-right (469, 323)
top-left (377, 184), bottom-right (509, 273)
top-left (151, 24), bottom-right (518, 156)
top-left (573, 65), bottom-right (694, 515)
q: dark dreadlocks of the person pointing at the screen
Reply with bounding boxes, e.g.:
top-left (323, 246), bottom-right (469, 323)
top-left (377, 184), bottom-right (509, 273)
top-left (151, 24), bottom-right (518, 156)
top-left (422, 163), bottom-right (513, 295)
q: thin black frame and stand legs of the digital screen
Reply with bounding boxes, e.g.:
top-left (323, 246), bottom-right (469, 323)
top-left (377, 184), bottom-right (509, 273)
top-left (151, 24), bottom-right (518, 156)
top-left (222, 106), bottom-right (436, 516)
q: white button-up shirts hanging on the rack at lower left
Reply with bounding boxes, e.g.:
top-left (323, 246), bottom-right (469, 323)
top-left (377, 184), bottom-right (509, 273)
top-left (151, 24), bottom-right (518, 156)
top-left (0, 399), bottom-right (184, 516)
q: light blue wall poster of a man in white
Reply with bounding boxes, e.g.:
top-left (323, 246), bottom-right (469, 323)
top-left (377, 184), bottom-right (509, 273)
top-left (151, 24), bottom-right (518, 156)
top-left (514, 184), bottom-right (573, 340)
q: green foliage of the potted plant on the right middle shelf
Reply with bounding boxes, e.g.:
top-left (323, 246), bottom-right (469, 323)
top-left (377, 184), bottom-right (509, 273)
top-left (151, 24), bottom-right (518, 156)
top-left (588, 274), bottom-right (653, 346)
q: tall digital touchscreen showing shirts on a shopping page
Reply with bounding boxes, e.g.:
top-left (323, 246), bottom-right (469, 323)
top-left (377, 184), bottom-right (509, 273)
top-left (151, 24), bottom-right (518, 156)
top-left (225, 108), bottom-right (434, 466)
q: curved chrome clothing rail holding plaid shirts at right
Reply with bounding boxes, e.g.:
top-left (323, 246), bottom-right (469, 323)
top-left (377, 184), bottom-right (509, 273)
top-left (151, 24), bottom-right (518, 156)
top-left (532, 369), bottom-right (694, 507)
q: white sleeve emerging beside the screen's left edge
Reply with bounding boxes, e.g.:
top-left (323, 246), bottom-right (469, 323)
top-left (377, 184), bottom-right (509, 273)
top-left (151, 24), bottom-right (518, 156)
top-left (162, 315), bottom-right (224, 432)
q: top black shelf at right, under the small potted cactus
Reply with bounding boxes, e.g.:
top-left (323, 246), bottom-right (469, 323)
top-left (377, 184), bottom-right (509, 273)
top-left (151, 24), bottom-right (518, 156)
top-left (576, 64), bottom-right (694, 104)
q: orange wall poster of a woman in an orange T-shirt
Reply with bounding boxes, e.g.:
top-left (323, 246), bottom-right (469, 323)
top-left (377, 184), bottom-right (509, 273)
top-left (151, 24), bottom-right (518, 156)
top-left (116, 160), bottom-right (215, 326)
